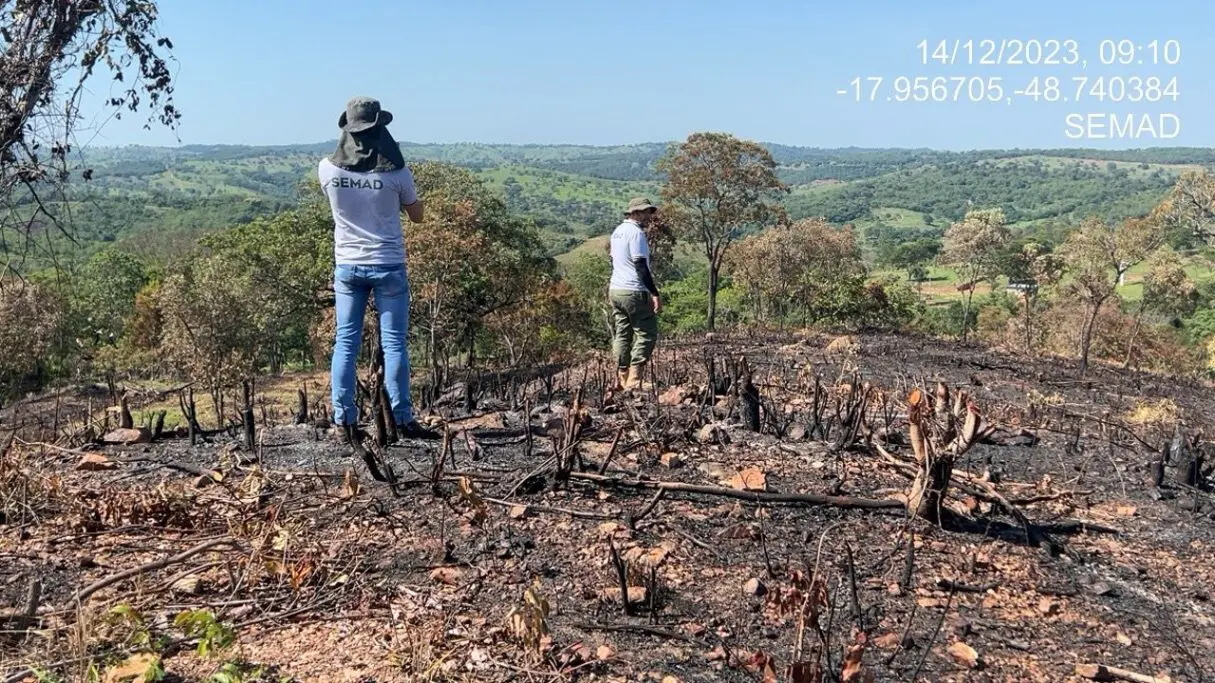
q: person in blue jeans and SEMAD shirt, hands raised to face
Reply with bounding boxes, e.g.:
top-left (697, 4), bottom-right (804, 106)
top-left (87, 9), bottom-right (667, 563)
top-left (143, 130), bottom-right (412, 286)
top-left (317, 97), bottom-right (437, 466)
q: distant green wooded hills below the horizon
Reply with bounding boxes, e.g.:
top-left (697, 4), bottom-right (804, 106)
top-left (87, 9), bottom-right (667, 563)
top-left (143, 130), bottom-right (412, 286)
top-left (26, 142), bottom-right (1215, 263)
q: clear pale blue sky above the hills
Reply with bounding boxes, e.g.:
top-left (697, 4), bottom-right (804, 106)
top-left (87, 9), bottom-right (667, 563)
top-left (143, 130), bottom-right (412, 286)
top-left (83, 0), bottom-right (1215, 149)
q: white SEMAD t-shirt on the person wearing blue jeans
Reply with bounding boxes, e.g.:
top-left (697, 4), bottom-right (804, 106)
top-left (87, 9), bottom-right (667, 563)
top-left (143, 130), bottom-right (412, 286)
top-left (317, 159), bottom-right (418, 266)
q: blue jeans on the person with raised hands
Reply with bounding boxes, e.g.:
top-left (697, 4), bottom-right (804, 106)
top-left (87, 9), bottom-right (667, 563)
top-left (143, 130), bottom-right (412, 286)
top-left (330, 264), bottom-right (413, 424)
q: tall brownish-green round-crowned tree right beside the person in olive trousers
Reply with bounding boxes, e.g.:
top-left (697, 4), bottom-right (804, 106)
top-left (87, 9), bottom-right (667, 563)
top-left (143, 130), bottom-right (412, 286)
top-left (656, 132), bottom-right (789, 329)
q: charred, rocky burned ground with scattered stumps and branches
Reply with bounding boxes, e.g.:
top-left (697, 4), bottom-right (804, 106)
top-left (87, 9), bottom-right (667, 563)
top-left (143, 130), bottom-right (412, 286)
top-left (0, 334), bottom-right (1215, 682)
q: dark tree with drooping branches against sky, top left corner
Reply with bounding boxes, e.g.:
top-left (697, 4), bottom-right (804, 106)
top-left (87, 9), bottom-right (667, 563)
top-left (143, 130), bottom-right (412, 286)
top-left (0, 0), bottom-right (179, 269)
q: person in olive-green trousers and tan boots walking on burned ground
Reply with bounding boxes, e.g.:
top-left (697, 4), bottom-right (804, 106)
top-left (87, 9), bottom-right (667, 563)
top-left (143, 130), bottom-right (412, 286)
top-left (608, 197), bottom-right (662, 389)
